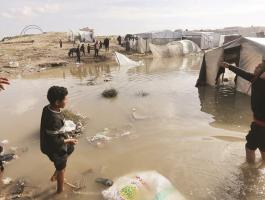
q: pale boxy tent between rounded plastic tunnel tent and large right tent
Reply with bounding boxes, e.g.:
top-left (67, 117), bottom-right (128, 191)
top-left (183, 31), bottom-right (220, 50)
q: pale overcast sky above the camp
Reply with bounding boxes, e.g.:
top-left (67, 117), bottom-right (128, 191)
top-left (0, 0), bottom-right (265, 38)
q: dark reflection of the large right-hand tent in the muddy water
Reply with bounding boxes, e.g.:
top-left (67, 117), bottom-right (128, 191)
top-left (198, 85), bottom-right (252, 132)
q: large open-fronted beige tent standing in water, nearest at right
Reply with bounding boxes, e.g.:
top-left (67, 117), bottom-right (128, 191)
top-left (196, 37), bottom-right (265, 94)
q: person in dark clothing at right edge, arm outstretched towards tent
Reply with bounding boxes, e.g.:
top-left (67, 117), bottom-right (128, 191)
top-left (222, 57), bottom-right (265, 163)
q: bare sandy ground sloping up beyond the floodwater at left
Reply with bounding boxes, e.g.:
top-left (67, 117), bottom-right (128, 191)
top-left (0, 32), bottom-right (145, 77)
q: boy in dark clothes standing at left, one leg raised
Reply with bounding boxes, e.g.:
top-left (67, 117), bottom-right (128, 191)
top-left (40, 86), bottom-right (78, 193)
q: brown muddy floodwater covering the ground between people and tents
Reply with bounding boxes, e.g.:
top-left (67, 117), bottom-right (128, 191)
top-left (0, 55), bottom-right (260, 200)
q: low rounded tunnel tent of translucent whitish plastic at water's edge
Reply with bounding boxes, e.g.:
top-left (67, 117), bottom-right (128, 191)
top-left (149, 40), bottom-right (201, 58)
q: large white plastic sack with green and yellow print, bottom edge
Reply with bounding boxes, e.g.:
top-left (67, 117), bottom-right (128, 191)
top-left (102, 171), bottom-right (185, 200)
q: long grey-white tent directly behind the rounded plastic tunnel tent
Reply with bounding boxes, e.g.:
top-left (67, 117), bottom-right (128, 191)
top-left (135, 30), bottom-right (182, 53)
